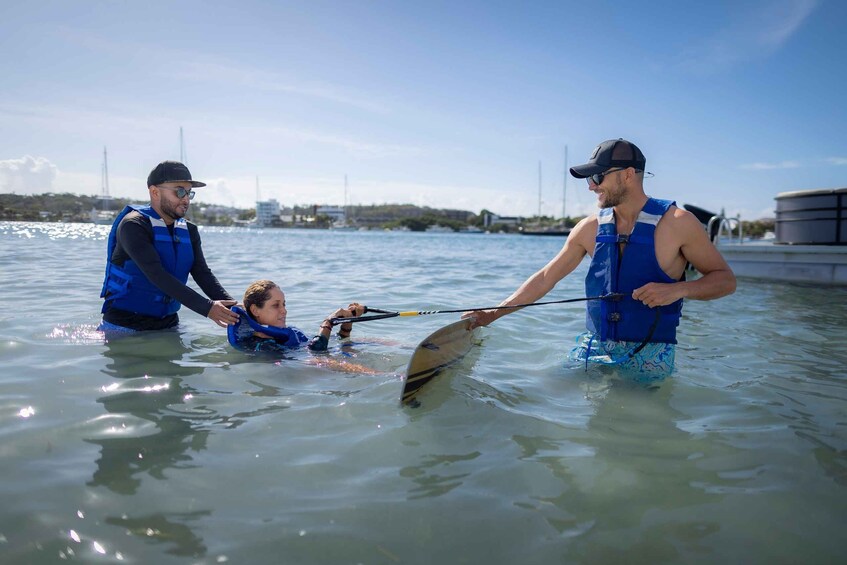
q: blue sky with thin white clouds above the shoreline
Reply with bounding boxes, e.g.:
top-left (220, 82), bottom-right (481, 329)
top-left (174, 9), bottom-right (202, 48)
top-left (0, 0), bottom-right (847, 219)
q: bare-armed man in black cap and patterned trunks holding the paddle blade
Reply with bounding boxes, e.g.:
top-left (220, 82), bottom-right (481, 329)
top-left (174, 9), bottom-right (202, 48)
top-left (464, 139), bottom-right (735, 374)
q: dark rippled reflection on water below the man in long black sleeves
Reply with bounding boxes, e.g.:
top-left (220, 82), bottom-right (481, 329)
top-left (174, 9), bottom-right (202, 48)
top-left (86, 332), bottom-right (214, 557)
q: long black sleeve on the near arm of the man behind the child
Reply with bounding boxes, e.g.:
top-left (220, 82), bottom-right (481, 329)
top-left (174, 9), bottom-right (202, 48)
top-left (112, 214), bottom-right (222, 317)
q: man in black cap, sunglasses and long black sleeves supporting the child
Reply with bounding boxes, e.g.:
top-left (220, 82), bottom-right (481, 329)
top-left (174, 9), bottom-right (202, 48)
top-left (100, 161), bottom-right (238, 330)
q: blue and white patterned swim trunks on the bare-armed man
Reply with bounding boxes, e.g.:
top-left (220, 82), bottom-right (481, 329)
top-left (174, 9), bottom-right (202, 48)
top-left (569, 332), bottom-right (676, 378)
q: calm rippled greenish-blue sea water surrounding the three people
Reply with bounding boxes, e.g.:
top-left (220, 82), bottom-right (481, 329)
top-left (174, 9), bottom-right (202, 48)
top-left (0, 223), bottom-right (847, 564)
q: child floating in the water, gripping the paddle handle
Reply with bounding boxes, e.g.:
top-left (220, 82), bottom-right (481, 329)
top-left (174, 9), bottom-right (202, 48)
top-left (227, 280), bottom-right (365, 352)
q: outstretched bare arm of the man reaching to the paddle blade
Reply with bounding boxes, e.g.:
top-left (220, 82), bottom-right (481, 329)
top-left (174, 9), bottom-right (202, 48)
top-left (462, 216), bottom-right (597, 327)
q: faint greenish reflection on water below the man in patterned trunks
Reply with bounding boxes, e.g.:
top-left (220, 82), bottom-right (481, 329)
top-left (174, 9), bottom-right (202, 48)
top-left (512, 379), bottom-right (735, 563)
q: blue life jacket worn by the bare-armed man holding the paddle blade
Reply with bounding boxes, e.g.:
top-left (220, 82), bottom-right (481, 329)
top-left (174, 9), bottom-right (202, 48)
top-left (585, 198), bottom-right (685, 343)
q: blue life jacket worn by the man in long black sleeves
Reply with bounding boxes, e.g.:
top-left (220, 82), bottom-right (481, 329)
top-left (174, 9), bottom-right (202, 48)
top-left (100, 205), bottom-right (194, 318)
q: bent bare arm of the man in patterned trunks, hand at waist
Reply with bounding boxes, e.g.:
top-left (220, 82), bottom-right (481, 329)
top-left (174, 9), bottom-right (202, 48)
top-left (632, 208), bottom-right (735, 307)
